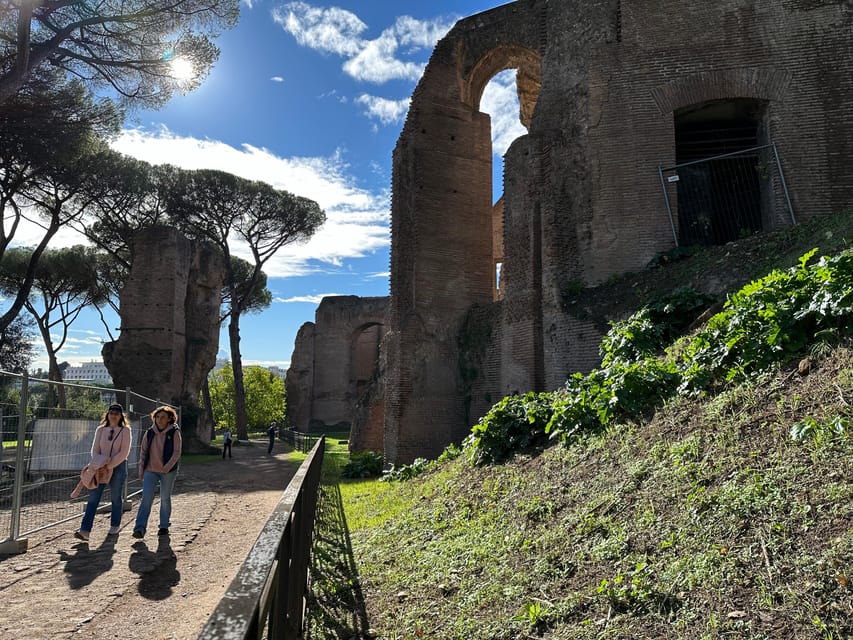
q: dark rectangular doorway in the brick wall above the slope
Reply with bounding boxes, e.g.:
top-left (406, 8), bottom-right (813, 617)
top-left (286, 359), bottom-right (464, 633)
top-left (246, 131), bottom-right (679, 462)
top-left (675, 100), bottom-right (765, 246)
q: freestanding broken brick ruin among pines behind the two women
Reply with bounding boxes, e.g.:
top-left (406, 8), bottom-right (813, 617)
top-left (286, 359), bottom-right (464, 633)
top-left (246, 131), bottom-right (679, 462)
top-left (102, 227), bottom-right (225, 452)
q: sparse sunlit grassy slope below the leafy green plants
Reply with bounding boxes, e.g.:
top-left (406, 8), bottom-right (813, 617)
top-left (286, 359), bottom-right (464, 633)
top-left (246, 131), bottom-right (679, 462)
top-left (309, 216), bottom-right (853, 640)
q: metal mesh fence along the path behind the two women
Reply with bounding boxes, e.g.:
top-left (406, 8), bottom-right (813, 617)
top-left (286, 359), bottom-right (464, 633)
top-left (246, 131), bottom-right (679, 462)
top-left (0, 371), bottom-right (178, 554)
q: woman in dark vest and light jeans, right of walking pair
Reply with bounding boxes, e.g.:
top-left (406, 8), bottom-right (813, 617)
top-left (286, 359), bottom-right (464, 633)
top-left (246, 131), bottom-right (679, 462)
top-left (133, 406), bottom-right (182, 538)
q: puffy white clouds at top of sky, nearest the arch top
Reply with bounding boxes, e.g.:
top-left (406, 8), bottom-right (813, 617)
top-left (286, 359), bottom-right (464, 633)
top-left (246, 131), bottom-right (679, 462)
top-left (272, 2), bottom-right (457, 83)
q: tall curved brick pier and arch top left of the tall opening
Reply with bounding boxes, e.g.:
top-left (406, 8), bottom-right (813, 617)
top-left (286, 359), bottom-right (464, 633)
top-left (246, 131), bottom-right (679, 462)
top-left (384, 2), bottom-right (544, 463)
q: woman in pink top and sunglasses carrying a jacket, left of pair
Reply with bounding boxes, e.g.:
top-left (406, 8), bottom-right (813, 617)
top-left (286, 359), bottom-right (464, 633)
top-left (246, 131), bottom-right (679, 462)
top-left (72, 404), bottom-right (132, 541)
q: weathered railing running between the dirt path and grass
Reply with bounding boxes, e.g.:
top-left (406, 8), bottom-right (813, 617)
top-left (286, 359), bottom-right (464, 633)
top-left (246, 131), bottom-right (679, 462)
top-left (198, 437), bottom-right (326, 640)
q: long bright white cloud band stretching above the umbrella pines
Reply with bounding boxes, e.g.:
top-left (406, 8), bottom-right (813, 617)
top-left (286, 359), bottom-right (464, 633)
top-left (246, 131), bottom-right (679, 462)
top-left (113, 129), bottom-right (390, 278)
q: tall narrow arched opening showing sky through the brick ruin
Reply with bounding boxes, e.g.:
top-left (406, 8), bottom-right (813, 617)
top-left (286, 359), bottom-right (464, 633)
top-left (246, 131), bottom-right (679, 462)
top-left (466, 46), bottom-right (541, 300)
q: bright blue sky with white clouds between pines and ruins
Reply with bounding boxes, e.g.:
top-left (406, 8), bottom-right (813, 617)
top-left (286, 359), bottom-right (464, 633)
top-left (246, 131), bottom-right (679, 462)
top-left (21, 0), bottom-right (524, 367)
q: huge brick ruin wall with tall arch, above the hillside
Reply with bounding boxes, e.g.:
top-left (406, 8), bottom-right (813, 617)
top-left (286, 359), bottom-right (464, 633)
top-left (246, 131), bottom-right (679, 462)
top-left (385, 0), bottom-right (853, 463)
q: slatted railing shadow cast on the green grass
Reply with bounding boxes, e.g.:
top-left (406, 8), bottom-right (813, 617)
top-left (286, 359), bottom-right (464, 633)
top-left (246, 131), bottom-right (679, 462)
top-left (304, 482), bottom-right (370, 640)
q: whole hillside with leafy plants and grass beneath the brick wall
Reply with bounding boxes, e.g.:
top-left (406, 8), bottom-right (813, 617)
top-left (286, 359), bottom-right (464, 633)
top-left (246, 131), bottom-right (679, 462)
top-left (307, 215), bottom-right (853, 640)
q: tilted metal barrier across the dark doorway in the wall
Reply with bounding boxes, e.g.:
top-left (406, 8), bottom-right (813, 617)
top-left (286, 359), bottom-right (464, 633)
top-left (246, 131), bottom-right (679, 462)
top-left (658, 144), bottom-right (796, 246)
